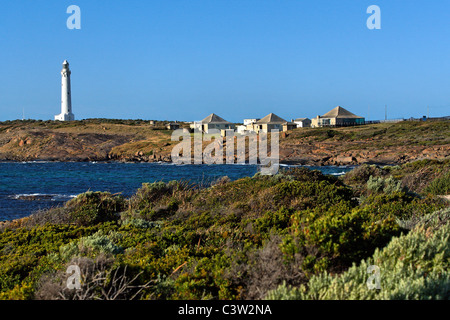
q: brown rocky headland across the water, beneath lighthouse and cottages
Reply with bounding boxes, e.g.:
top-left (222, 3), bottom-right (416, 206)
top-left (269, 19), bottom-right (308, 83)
top-left (0, 119), bottom-right (450, 166)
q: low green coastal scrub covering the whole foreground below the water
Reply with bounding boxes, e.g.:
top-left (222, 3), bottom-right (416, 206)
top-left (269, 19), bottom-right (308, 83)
top-left (0, 160), bottom-right (450, 299)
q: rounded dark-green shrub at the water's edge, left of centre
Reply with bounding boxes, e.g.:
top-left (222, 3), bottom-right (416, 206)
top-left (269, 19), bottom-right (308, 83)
top-left (65, 191), bottom-right (125, 226)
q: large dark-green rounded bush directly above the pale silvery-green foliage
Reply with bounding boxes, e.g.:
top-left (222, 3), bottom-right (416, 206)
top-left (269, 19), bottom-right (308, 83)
top-left (283, 202), bottom-right (399, 273)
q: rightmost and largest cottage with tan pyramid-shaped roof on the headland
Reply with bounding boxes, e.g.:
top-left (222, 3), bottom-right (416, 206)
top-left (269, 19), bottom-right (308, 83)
top-left (311, 106), bottom-right (365, 128)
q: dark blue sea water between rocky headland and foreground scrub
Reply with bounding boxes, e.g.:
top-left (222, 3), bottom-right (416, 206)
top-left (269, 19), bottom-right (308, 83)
top-left (0, 161), bottom-right (352, 221)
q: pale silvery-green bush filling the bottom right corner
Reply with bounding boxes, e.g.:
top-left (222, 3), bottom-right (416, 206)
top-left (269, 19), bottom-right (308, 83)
top-left (266, 219), bottom-right (450, 300)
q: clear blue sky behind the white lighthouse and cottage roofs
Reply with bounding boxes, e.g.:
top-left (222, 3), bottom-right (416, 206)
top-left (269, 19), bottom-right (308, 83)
top-left (0, 0), bottom-right (450, 122)
